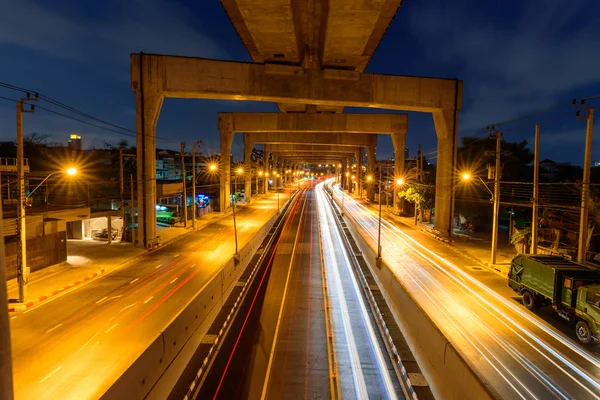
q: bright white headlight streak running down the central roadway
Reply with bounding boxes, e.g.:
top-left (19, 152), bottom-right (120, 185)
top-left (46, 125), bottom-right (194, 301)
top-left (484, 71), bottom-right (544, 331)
top-left (316, 183), bottom-right (397, 399)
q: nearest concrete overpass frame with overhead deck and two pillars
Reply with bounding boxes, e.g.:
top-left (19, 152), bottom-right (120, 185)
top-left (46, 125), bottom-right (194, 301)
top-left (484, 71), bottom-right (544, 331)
top-left (131, 0), bottom-right (462, 247)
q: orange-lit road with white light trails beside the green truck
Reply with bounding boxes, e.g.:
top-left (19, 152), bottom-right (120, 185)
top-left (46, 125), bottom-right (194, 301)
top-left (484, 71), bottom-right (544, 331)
top-left (335, 182), bottom-right (600, 399)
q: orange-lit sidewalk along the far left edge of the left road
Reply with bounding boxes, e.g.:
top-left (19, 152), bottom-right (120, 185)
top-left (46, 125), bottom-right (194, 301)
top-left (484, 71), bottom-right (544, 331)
top-left (6, 205), bottom-right (258, 312)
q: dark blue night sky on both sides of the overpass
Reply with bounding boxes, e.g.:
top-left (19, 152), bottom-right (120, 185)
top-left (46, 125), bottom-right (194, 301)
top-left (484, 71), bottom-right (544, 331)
top-left (0, 0), bottom-right (600, 164)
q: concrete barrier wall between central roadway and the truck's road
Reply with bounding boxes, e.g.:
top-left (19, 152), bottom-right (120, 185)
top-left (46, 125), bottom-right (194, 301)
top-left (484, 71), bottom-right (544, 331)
top-left (336, 198), bottom-right (501, 400)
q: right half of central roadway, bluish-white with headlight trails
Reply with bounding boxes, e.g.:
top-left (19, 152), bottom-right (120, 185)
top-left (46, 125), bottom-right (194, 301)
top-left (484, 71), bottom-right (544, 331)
top-left (316, 183), bottom-right (404, 399)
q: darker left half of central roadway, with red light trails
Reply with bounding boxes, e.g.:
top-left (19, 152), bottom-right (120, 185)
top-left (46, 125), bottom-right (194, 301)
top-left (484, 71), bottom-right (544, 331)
top-left (194, 183), bottom-right (330, 399)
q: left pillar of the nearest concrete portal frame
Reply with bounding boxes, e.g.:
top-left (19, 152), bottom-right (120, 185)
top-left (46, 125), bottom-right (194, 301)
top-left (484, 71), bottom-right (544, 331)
top-left (134, 73), bottom-right (163, 247)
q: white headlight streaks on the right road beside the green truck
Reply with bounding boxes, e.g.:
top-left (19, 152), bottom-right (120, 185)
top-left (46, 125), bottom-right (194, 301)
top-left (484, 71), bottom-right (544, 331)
top-left (328, 184), bottom-right (600, 398)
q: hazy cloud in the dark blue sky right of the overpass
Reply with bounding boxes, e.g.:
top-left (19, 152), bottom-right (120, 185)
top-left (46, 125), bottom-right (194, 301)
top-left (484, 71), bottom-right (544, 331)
top-left (410, 0), bottom-right (600, 134)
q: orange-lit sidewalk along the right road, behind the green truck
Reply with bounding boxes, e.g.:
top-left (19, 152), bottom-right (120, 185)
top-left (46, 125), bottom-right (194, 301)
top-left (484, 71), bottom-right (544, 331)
top-left (357, 199), bottom-right (517, 275)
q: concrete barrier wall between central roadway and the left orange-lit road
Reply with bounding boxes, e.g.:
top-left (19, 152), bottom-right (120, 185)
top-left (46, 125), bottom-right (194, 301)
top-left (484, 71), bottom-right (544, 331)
top-left (102, 200), bottom-right (289, 400)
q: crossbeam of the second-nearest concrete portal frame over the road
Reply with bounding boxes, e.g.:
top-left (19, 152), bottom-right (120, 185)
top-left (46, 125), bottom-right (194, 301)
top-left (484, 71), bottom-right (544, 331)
top-left (219, 113), bottom-right (408, 134)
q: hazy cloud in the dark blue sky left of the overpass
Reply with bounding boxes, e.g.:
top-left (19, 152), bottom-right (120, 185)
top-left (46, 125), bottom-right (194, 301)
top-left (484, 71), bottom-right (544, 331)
top-left (0, 0), bottom-right (227, 74)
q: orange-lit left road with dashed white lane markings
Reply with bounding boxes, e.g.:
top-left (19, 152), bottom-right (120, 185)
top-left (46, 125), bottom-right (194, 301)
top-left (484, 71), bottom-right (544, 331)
top-left (11, 195), bottom-right (287, 399)
